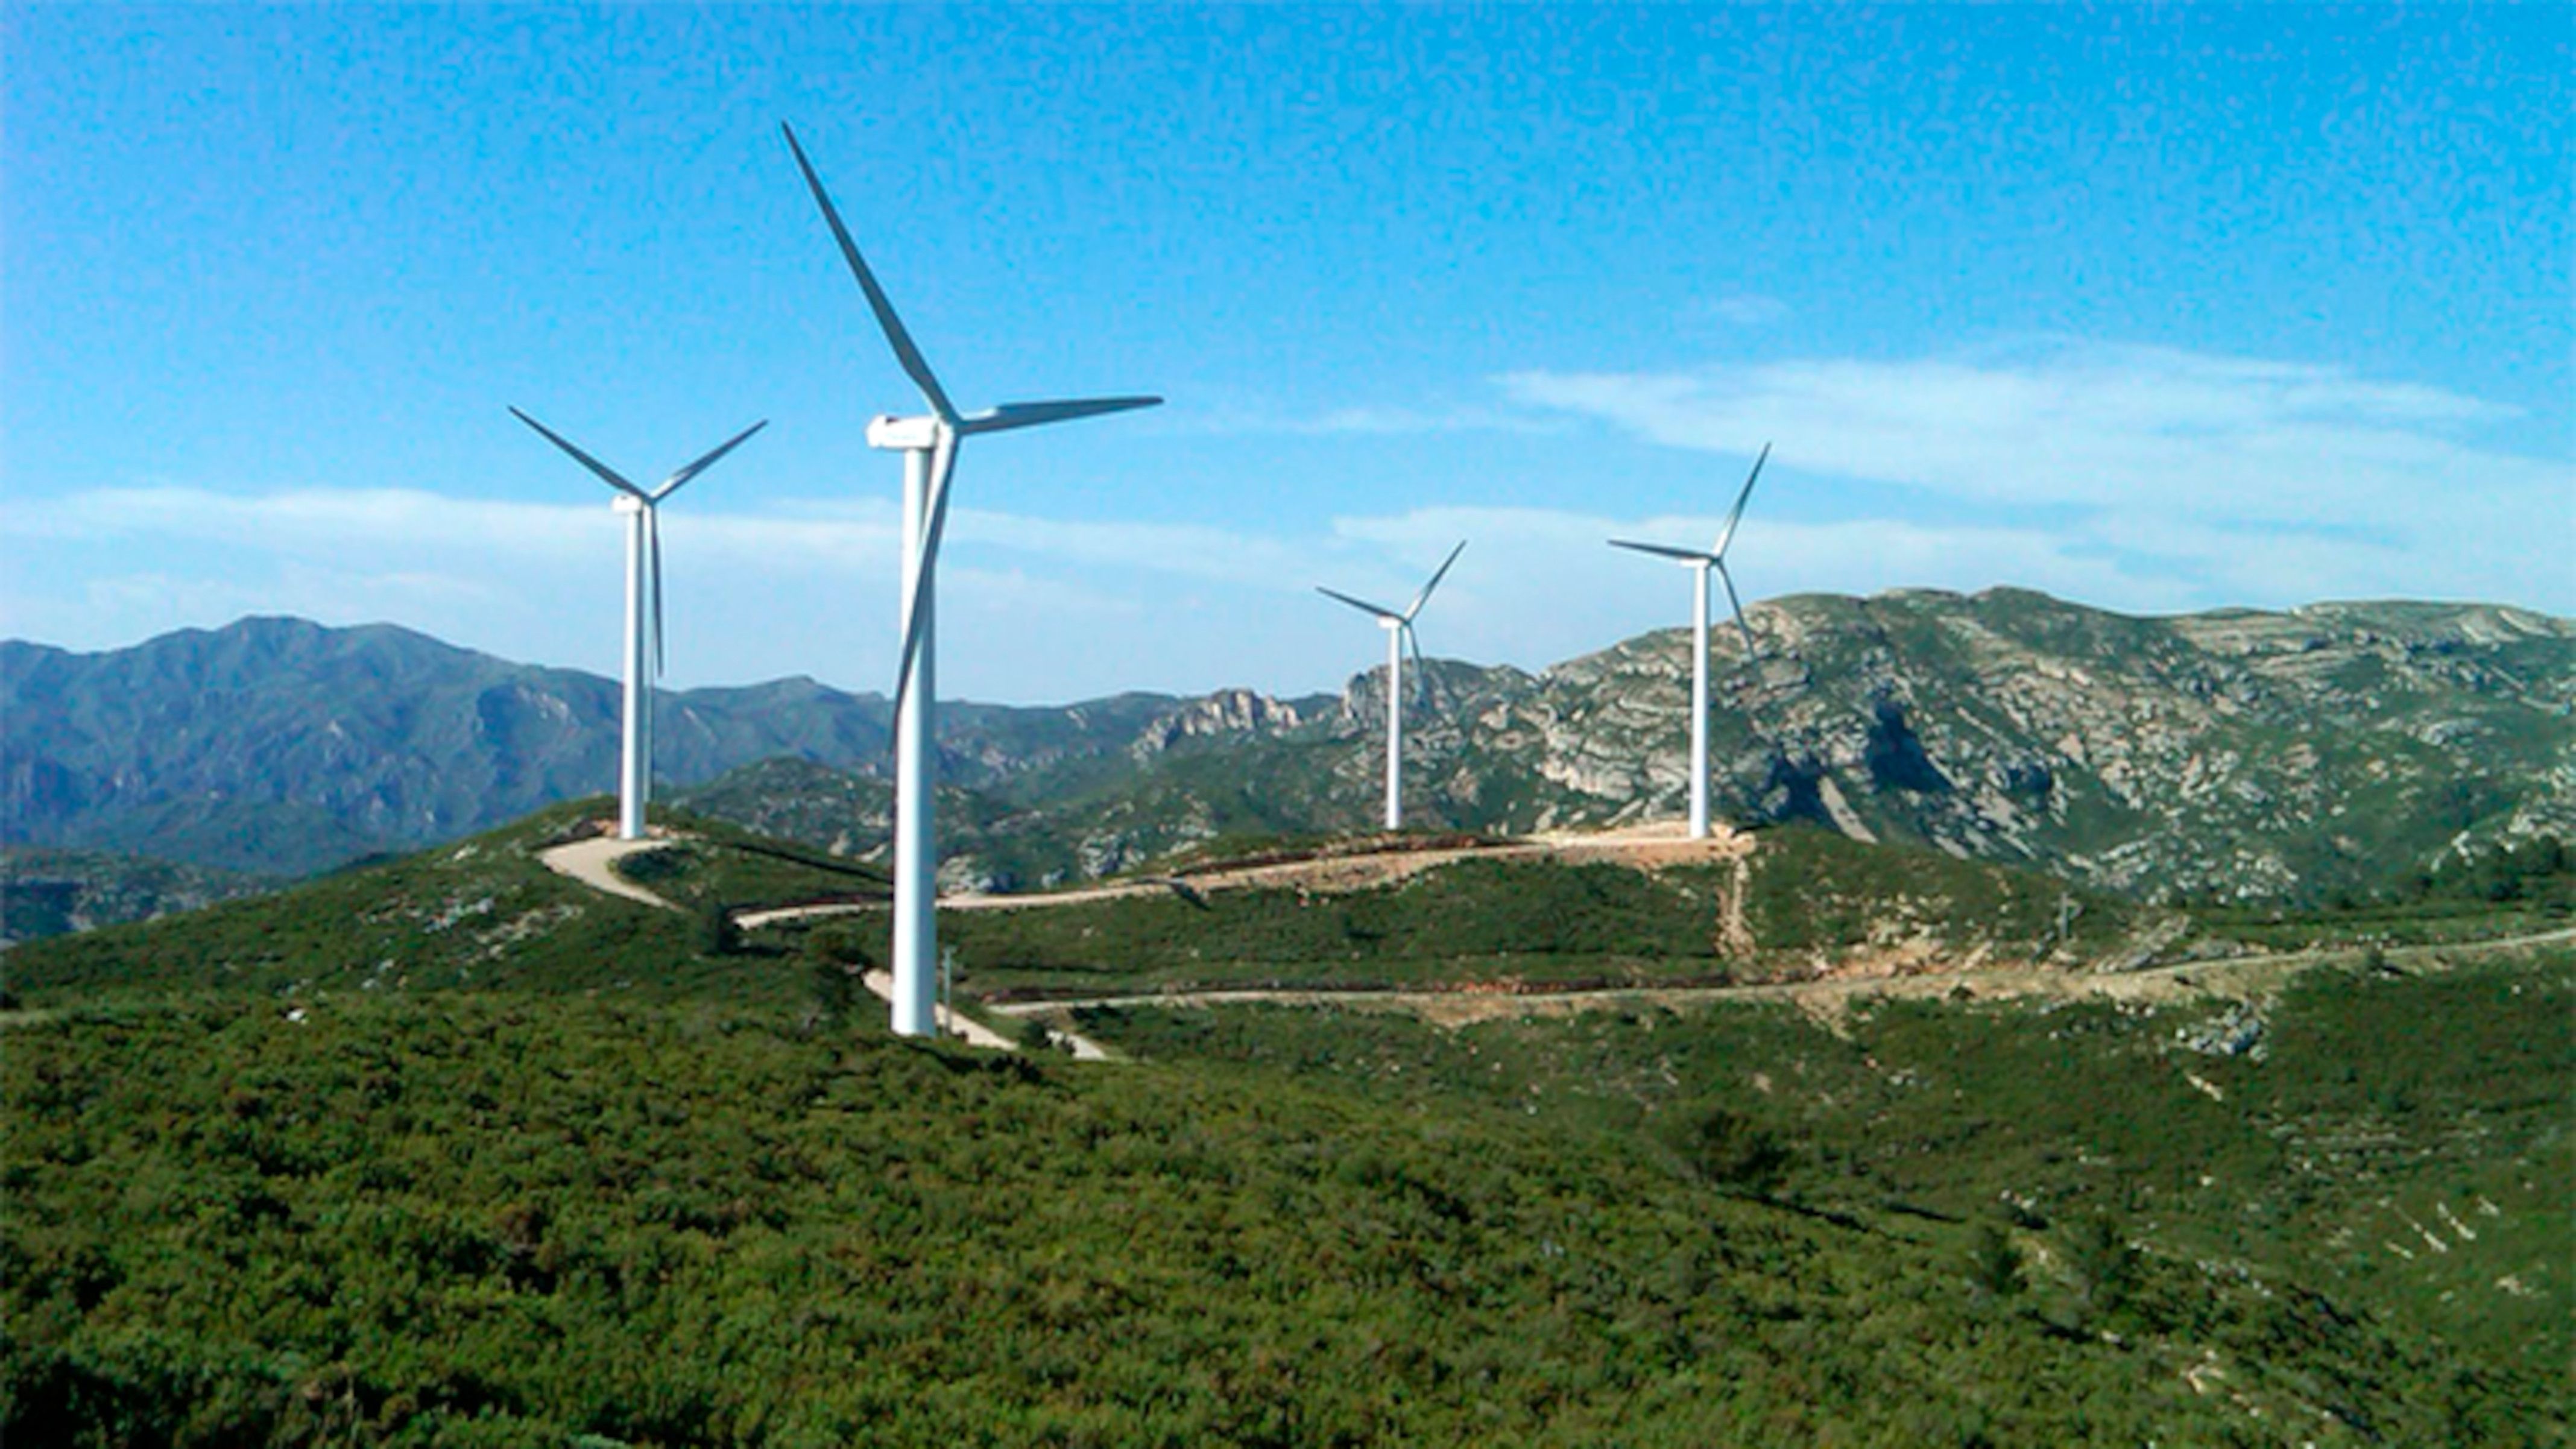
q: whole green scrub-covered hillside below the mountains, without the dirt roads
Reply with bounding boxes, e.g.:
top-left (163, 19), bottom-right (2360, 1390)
top-left (0, 802), bottom-right (2576, 1447)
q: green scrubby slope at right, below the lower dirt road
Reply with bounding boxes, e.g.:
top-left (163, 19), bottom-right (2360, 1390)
top-left (1077, 946), bottom-right (2576, 1392)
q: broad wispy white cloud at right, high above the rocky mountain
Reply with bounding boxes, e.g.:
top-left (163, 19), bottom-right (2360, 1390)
top-left (1502, 338), bottom-right (2576, 604)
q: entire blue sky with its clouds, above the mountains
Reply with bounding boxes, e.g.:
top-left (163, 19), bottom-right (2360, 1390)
top-left (0, 5), bottom-right (2576, 701)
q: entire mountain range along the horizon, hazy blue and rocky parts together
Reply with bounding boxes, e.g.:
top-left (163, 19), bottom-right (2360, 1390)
top-left (0, 590), bottom-right (2576, 895)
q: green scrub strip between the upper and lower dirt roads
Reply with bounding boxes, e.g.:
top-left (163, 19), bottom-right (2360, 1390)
top-left (752, 825), bottom-right (2174, 1000)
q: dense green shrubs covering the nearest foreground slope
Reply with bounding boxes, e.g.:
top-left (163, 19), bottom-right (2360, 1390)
top-left (0, 993), bottom-right (2553, 1447)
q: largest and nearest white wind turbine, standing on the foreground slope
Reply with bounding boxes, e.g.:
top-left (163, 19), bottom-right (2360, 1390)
top-left (778, 124), bottom-right (1162, 1037)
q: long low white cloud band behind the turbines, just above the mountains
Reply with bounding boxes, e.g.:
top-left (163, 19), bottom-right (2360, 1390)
top-left (0, 477), bottom-right (2091, 701)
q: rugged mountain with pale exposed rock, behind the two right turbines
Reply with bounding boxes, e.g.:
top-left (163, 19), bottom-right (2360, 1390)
top-left (1195, 590), bottom-right (2576, 897)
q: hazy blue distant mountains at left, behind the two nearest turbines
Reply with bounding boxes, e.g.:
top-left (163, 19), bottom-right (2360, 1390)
top-left (0, 619), bottom-right (1167, 874)
